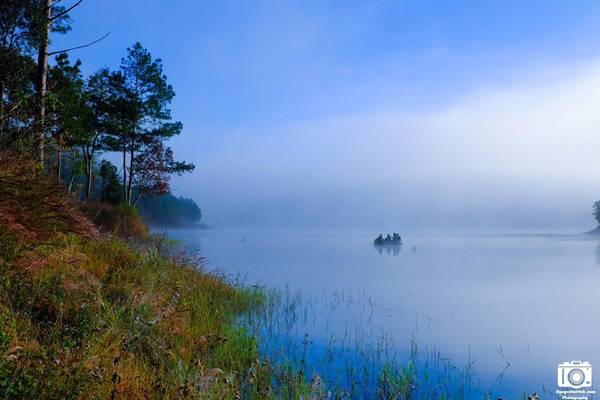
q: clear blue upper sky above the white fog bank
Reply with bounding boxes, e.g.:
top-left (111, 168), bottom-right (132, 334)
top-left (55, 0), bottom-right (600, 128)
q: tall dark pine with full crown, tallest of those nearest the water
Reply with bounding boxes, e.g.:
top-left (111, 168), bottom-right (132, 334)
top-left (106, 43), bottom-right (193, 205)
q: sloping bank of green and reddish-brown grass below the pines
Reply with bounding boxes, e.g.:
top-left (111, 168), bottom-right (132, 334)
top-left (0, 160), bottom-right (270, 399)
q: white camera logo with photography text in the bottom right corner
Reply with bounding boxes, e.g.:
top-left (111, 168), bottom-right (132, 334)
top-left (556, 361), bottom-right (596, 400)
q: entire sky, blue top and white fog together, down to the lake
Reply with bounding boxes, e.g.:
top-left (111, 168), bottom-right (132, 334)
top-left (53, 0), bottom-right (600, 228)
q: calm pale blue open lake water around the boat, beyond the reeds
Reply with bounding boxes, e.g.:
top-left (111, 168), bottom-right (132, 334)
top-left (164, 230), bottom-right (600, 397)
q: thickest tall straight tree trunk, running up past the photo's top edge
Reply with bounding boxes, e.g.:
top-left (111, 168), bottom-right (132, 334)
top-left (34, 0), bottom-right (52, 165)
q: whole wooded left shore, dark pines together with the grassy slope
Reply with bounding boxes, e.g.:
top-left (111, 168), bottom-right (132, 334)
top-left (0, 0), bottom-right (272, 399)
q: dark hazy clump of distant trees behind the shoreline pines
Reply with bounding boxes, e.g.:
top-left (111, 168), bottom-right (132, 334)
top-left (138, 193), bottom-right (202, 227)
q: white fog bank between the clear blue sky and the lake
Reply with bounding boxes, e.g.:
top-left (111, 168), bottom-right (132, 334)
top-left (176, 62), bottom-right (600, 232)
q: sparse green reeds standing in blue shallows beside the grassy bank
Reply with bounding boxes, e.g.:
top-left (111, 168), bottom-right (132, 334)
top-left (241, 288), bottom-right (536, 400)
